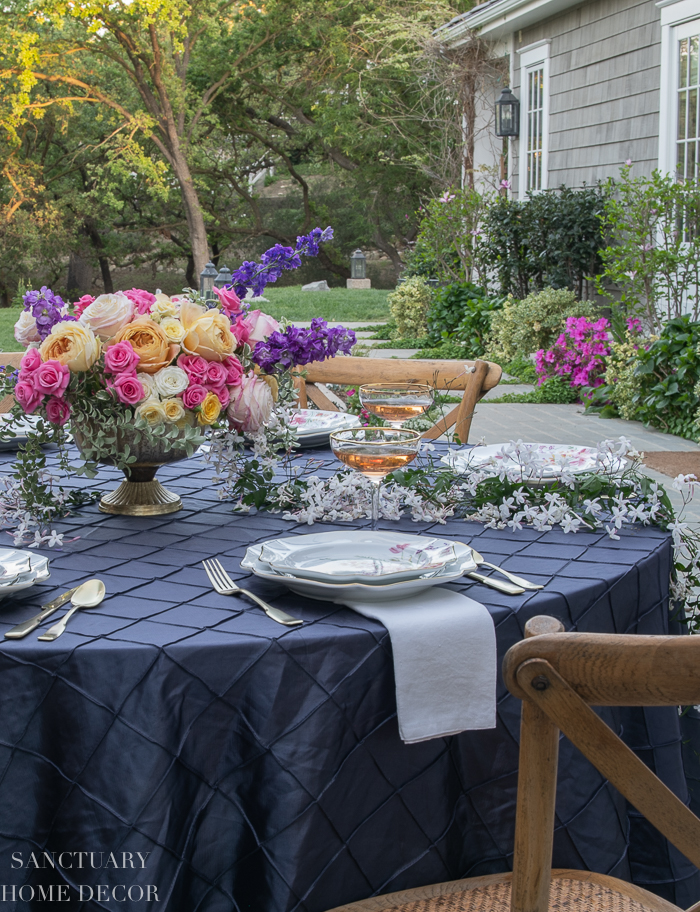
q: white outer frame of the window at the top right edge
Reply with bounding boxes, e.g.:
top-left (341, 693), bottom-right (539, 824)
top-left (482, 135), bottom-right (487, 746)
top-left (656, 0), bottom-right (700, 174)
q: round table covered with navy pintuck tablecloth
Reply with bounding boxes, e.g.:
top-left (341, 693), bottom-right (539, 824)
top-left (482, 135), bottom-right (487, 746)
top-left (0, 449), bottom-right (700, 912)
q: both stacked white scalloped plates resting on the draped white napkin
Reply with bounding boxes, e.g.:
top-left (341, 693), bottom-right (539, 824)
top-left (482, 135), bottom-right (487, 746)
top-left (241, 532), bottom-right (476, 602)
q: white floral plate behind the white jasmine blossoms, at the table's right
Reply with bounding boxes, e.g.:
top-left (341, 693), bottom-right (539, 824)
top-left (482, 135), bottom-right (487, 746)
top-left (441, 443), bottom-right (625, 479)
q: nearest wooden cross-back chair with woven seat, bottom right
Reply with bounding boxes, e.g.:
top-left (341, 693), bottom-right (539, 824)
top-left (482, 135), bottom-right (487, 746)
top-left (332, 617), bottom-right (700, 912)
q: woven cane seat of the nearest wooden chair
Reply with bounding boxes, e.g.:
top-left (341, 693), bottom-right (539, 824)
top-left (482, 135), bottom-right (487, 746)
top-left (331, 871), bottom-right (681, 912)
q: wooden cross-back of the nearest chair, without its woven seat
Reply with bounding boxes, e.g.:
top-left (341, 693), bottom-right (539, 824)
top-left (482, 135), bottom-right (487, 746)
top-left (503, 617), bottom-right (700, 912)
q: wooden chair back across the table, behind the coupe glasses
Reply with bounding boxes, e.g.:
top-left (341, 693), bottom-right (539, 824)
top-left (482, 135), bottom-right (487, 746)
top-left (297, 357), bottom-right (503, 443)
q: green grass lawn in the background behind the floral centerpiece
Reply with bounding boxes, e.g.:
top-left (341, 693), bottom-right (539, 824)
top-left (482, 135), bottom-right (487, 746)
top-left (0, 285), bottom-right (390, 351)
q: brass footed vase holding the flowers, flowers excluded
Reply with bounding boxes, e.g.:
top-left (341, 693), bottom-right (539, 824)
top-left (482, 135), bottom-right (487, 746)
top-left (72, 422), bottom-right (187, 516)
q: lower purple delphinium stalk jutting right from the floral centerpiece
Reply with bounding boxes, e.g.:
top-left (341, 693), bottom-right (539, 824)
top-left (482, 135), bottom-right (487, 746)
top-left (251, 317), bottom-right (356, 374)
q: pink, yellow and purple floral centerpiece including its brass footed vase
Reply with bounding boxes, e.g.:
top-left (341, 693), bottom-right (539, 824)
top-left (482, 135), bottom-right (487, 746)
top-left (2, 228), bottom-right (355, 513)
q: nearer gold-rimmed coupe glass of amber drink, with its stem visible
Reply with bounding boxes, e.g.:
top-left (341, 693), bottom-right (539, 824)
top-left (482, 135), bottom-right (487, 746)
top-left (331, 427), bottom-right (421, 532)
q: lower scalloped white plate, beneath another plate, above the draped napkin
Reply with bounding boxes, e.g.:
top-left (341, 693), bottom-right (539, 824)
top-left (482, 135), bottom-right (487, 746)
top-left (241, 542), bottom-right (476, 603)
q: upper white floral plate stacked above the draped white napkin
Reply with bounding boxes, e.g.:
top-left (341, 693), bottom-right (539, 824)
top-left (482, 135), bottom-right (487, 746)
top-left (260, 531), bottom-right (470, 584)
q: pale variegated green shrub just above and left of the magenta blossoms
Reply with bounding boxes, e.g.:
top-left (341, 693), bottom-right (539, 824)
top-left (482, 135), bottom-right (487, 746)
top-left (486, 288), bottom-right (598, 361)
